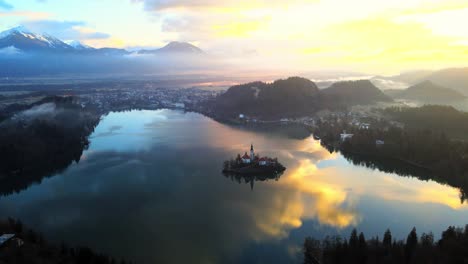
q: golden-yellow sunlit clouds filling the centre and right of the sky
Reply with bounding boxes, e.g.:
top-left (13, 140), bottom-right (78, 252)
top-left (144, 0), bottom-right (468, 73)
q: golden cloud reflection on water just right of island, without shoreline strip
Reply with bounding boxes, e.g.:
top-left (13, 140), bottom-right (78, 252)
top-left (245, 139), bottom-right (360, 241)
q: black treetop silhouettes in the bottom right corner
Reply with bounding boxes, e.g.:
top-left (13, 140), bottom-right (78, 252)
top-left (304, 225), bottom-right (468, 264)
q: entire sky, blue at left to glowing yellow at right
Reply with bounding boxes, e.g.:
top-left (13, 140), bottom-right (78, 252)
top-left (0, 0), bottom-right (468, 74)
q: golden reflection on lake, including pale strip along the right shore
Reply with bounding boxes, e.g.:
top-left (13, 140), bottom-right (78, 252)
top-left (252, 136), bottom-right (468, 240)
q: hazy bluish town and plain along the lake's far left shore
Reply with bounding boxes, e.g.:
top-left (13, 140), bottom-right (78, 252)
top-left (0, 81), bottom-right (224, 120)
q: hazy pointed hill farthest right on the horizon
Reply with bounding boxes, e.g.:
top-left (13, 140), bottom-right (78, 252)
top-left (393, 81), bottom-right (465, 103)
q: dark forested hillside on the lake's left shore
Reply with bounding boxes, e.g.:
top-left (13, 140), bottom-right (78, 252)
top-left (0, 97), bottom-right (100, 195)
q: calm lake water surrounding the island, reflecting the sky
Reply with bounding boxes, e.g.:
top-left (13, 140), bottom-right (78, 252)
top-left (0, 110), bottom-right (468, 263)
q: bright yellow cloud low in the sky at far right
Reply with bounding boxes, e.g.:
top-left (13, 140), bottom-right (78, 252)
top-left (322, 18), bottom-right (467, 67)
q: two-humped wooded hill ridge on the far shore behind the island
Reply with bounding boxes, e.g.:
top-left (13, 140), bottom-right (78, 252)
top-left (204, 77), bottom-right (392, 119)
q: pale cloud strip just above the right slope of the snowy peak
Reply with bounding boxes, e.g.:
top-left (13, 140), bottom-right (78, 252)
top-left (23, 20), bottom-right (110, 40)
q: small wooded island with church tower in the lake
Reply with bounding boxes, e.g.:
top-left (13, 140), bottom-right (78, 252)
top-left (223, 144), bottom-right (286, 175)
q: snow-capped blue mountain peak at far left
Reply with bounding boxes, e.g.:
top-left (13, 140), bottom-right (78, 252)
top-left (0, 26), bottom-right (73, 52)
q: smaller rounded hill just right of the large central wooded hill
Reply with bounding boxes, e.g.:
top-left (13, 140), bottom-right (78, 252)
top-left (321, 80), bottom-right (392, 106)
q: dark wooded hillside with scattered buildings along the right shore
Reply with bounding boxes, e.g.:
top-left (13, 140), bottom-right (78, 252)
top-left (314, 105), bottom-right (468, 203)
